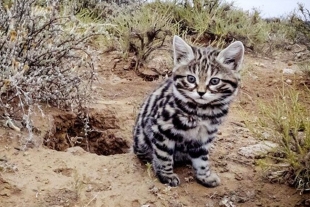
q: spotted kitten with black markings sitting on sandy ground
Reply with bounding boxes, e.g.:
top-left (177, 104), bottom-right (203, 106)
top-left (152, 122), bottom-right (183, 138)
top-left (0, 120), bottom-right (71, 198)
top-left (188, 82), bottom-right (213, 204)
top-left (133, 36), bottom-right (244, 187)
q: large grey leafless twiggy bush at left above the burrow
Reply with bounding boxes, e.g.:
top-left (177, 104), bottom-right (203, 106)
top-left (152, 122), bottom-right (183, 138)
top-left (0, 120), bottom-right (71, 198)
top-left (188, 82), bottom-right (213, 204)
top-left (0, 0), bottom-right (96, 141)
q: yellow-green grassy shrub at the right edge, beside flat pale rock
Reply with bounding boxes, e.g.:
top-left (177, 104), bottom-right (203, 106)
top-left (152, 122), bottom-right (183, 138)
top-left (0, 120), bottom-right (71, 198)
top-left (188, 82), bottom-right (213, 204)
top-left (258, 86), bottom-right (310, 192)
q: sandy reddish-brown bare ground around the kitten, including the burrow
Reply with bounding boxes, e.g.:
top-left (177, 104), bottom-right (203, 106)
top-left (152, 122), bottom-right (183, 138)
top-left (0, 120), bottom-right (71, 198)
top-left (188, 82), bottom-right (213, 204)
top-left (0, 50), bottom-right (310, 207)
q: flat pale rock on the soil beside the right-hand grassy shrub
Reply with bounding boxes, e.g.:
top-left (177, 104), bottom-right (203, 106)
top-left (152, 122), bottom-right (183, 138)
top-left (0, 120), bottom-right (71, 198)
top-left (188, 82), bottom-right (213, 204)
top-left (238, 141), bottom-right (278, 158)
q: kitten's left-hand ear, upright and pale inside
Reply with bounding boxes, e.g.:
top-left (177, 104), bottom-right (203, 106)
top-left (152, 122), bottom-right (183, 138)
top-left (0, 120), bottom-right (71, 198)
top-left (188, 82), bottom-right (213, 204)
top-left (173, 35), bottom-right (194, 65)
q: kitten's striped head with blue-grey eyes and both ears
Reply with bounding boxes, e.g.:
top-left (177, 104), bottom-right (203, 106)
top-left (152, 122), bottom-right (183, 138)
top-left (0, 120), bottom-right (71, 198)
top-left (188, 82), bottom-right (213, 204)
top-left (172, 36), bottom-right (244, 104)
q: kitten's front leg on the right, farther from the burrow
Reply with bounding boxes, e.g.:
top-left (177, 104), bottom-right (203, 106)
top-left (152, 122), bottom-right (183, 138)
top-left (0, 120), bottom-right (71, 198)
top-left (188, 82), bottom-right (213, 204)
top-left (189, 145), bottom-right (221, 187)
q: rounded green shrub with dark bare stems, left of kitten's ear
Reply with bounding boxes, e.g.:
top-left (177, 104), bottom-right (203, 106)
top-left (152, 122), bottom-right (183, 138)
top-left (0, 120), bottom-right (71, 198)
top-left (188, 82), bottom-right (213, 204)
top-left (105, 2), bottom-right (177, 69)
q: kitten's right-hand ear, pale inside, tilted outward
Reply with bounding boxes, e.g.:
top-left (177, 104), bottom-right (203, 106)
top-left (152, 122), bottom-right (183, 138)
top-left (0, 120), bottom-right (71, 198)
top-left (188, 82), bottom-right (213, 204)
top-left (216, 41), bottom-right (244, 71)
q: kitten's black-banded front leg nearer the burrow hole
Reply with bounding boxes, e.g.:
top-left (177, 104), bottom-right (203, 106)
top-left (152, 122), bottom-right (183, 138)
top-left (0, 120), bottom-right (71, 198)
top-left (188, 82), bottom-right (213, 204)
top-left (152, 133), bottom-right (180, 187)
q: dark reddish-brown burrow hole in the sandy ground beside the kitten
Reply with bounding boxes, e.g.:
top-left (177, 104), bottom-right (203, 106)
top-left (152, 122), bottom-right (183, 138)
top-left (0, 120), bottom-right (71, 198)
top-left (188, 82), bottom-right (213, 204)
top-left (44, 110), bottom-right (129, 155)
